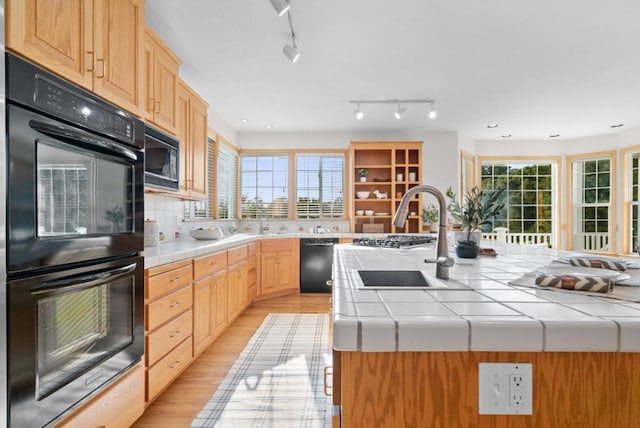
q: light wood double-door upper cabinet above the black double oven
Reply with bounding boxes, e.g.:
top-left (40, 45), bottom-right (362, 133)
top-left (6, 0), bottom-right (144, 116)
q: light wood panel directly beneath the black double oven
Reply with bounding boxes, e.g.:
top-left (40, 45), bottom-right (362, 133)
top-left (56, 362), bottom-right (144, 428)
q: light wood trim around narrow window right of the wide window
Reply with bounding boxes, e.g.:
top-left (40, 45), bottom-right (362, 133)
top-left (564, 150), bottom-right (618, 253)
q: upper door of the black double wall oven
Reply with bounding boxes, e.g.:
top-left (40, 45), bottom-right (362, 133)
top-left (7, 104), bottom-right (144, 272)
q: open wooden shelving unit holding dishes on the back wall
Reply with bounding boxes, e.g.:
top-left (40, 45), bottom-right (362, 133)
top-left (349, 141), bottom-right (422, 233)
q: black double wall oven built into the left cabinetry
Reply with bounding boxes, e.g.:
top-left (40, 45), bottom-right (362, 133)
top-left (5, 54), bottom-right (144, 427)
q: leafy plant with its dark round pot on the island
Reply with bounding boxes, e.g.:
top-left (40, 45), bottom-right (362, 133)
top-left (446, 186), bottom-right (504, 258)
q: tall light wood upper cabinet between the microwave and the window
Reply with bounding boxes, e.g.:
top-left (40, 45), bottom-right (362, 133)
top-left (177, 80), bottom-right (208, 199)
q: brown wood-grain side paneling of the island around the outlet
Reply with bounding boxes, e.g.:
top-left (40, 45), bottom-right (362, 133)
top-left (341, 352), bottom-right (640, 428)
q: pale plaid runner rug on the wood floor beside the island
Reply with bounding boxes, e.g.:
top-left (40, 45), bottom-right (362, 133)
top-left (191, 314), bottom-right (332, 428)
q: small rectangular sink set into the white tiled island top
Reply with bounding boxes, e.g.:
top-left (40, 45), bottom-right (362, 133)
top-left (352, 269), bottom-right (447, 289)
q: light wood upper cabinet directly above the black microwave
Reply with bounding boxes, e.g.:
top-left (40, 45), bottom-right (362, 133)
top-left (143, 27), bottom-right (180, 135)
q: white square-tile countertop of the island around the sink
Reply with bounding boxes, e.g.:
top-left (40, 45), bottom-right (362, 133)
top-left (333, 244), bottom-right (640, 352)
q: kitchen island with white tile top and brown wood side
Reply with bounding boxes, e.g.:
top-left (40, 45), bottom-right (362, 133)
top-left (333, 245), bottom-right (640, 427)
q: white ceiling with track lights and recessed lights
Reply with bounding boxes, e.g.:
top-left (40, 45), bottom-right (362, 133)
top-left (146, 0), bottom-right (640, 140)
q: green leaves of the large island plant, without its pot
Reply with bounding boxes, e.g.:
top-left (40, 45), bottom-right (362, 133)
top-left (446, 186), bottom-right (504, 241)
